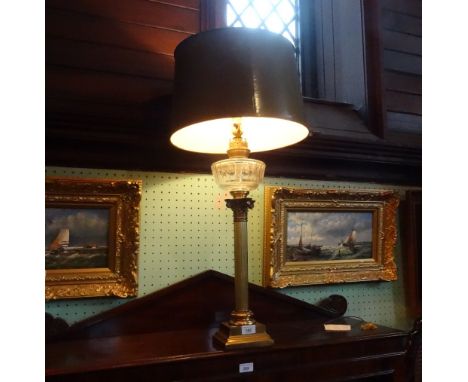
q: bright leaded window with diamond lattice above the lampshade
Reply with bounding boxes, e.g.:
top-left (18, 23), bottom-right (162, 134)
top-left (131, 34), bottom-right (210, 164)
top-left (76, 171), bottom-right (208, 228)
top-left (226, 0), bottom-right (298, 46)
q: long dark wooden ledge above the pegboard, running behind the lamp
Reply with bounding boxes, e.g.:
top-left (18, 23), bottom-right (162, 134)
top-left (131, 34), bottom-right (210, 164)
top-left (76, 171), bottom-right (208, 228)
top-left (46, 133), bottom-right (421, 186)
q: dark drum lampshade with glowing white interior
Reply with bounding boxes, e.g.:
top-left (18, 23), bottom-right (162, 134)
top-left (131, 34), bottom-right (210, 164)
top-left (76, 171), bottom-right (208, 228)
top-left (171, 28), bottom-right (309, 153)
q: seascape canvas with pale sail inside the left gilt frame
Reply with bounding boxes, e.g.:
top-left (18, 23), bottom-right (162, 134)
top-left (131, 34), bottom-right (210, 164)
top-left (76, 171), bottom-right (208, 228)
top-left (45, 208), bottom-right (109, 269)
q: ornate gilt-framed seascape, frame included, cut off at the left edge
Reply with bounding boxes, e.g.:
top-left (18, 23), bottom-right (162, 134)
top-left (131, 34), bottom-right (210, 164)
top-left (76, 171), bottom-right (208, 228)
top-left (45, 177), bottom-right (142, 300)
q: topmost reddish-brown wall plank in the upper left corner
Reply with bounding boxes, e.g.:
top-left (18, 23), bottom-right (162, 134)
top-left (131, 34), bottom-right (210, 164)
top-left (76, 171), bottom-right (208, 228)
top-left (46, 0), bottom-right (199, 33)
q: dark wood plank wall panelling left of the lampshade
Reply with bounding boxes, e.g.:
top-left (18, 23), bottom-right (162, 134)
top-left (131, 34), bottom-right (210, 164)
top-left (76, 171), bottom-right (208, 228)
top-left (46, 0), bottom-right (190, 168)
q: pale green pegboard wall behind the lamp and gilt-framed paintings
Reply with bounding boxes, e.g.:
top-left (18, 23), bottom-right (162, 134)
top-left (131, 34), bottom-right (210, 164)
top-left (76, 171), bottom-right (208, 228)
top-left (46, 167), bottom-right (416, 329)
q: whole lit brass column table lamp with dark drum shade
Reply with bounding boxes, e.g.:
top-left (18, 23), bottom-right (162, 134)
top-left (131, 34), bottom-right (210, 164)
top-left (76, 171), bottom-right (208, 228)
top-left (170, 28), bottom-right (309, 349)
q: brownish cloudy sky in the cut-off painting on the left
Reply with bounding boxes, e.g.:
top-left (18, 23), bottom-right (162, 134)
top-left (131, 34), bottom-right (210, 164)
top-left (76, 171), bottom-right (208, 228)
top-left (45, 208), bottom-right (109, 247)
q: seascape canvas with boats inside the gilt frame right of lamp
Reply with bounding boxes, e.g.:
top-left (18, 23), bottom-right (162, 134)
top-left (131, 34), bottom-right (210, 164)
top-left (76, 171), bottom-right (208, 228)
top-left (286, 211), bottom-right (372, 261)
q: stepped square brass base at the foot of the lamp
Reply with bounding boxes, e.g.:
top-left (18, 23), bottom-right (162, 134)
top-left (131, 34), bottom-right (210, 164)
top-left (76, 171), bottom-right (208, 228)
top-left (213, 322), bottom-right (274, 350)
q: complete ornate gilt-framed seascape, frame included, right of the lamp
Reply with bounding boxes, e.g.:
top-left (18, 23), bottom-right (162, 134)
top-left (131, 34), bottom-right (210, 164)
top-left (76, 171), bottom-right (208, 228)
top-left (263, 187), bottom-right (399, 288)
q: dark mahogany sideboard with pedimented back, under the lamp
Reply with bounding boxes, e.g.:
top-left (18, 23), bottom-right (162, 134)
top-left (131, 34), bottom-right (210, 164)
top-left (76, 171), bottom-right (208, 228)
top-left (45, 271), bottom-right (411, 382)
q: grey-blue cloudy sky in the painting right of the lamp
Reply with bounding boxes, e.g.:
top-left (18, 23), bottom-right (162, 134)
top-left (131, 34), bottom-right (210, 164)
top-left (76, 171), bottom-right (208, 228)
top-left (287, 212), bottom-right (372, 246)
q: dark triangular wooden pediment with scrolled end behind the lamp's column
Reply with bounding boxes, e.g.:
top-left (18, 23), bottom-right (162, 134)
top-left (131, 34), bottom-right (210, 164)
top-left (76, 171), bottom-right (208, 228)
top-left (52, 270), bottom-right (346, 340)
